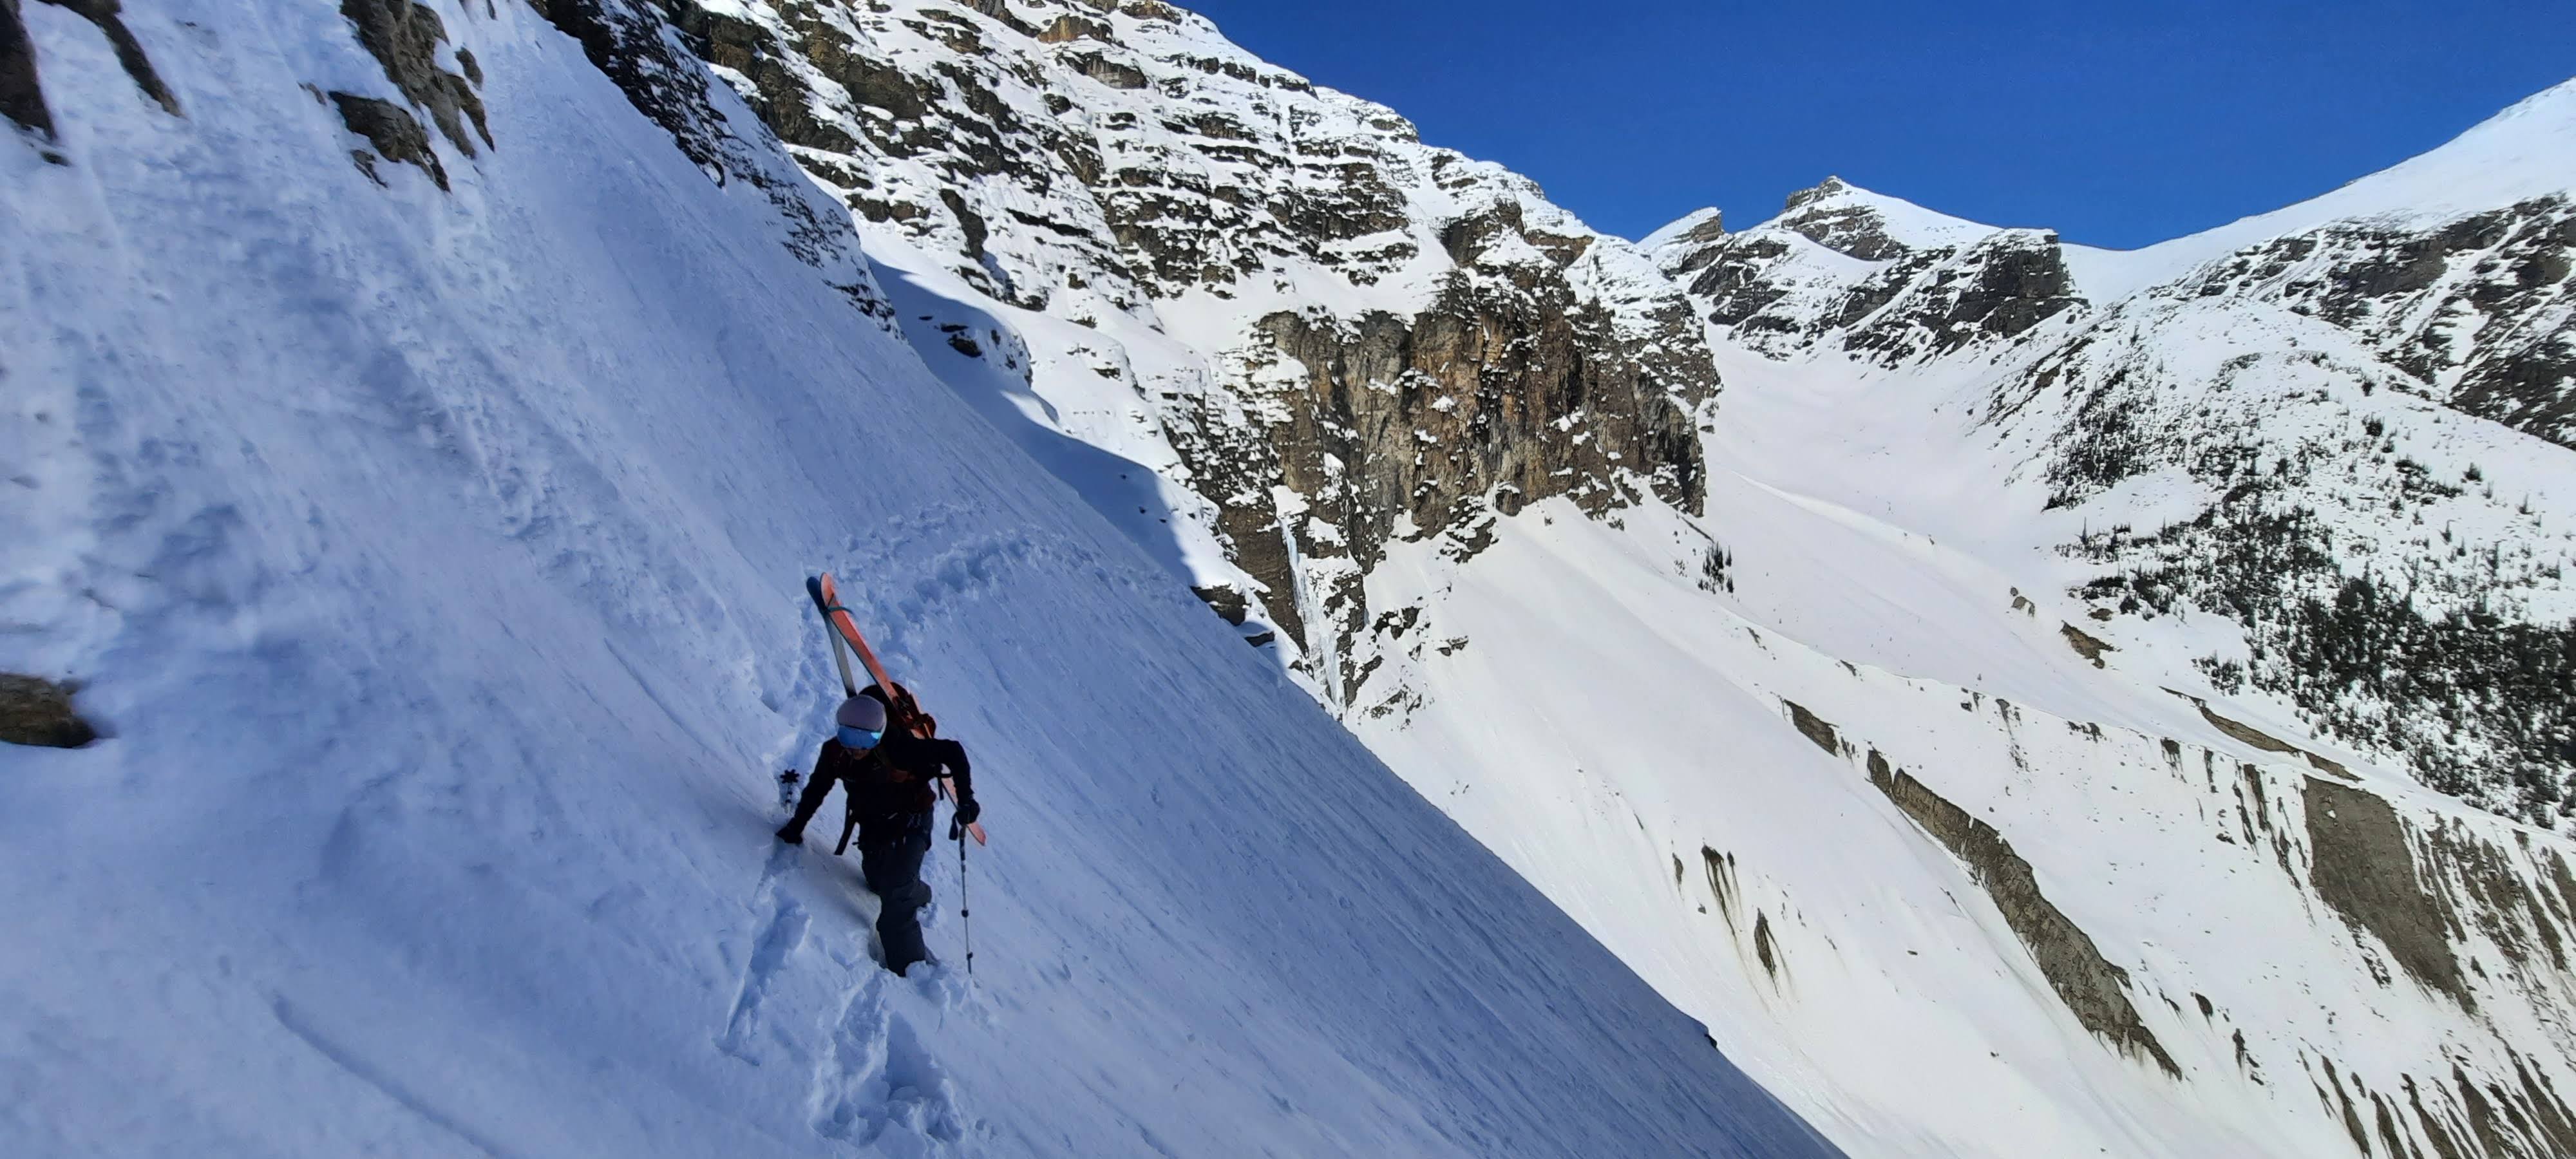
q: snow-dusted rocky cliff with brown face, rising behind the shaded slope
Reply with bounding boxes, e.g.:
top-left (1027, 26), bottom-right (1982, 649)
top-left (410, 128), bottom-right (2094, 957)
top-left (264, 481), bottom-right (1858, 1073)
top-left (644, 0), bottom-right (1718, 701)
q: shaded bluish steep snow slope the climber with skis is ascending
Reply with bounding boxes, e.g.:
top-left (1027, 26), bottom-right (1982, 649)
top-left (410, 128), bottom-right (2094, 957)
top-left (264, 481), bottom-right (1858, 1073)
top-left (0, 0), bottom-right (1832, 1156)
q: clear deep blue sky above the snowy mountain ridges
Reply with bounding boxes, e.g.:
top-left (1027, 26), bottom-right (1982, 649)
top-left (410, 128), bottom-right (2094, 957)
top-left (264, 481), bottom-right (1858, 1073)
top-left (1182, 0), bottom-right (2576, 247)
